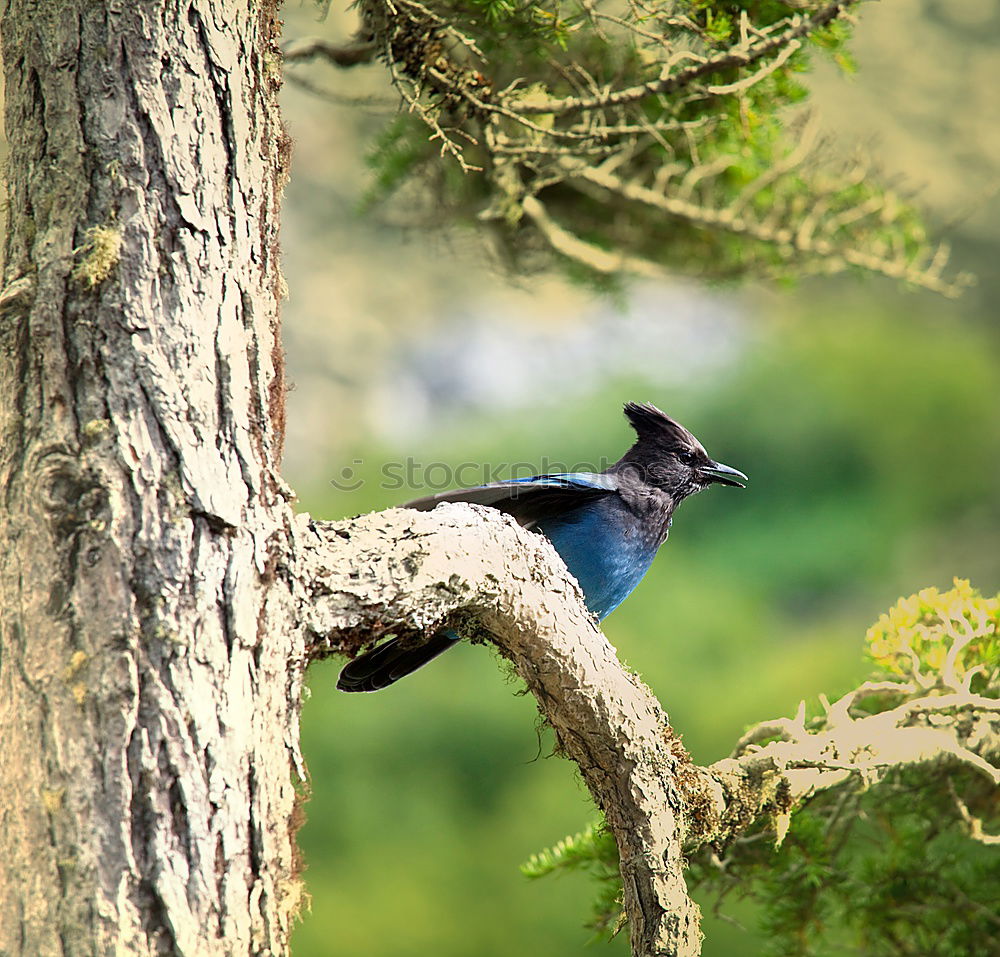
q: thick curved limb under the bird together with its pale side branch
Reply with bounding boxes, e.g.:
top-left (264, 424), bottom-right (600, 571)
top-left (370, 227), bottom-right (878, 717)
top-left (284, 504), bottom-right (1000, 957)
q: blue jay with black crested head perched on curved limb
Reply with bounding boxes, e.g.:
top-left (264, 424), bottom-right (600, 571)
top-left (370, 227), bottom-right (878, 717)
top-left (337, 402), bottom-right (749, 692)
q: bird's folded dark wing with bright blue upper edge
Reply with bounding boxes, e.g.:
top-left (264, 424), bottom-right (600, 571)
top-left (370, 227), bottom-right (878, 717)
top-left (405, 472), bottom-right (618, 526)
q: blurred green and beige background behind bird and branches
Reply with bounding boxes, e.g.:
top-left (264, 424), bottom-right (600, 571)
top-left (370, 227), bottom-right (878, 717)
top-left (284, 0), bottom-right (1000, 957)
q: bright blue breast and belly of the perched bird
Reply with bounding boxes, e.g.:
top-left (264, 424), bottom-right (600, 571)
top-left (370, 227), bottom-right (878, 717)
top-left (536, 496), bottom-right (659, 618)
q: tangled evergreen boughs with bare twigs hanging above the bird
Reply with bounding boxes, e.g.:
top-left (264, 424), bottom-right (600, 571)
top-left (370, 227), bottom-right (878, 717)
top-left (294, 0), bottom-right (967, 295)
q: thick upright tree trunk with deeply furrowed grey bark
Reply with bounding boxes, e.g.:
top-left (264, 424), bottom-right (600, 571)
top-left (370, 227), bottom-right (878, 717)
top-left (0, 0), bottom-right (303, 955)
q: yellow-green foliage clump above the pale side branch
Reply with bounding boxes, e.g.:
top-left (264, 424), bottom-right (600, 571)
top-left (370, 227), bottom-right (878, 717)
top-left (866, 578), bottom-right (1000, 687)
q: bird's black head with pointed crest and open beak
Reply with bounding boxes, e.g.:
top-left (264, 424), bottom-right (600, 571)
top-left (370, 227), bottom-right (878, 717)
top-left (619, 402), bottom-right (748, 502)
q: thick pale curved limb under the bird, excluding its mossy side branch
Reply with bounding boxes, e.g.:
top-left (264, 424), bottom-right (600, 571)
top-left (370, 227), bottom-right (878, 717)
top-left (304, 505), bottom-right (701, 957)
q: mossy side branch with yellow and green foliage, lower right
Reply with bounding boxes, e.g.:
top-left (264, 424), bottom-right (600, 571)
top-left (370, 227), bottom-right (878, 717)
top-left (523, 581), bottom-right (1000, 957)
